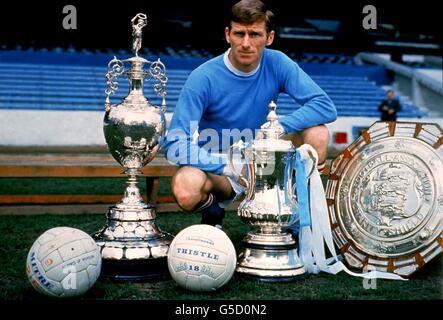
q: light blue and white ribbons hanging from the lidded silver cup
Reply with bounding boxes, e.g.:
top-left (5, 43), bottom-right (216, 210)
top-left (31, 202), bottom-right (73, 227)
top-left (295, 144), bottom-right (407, 280)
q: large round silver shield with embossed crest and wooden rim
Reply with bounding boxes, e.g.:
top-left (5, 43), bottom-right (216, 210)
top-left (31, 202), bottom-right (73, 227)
top-left (326, 122), bottom-right (443, 276)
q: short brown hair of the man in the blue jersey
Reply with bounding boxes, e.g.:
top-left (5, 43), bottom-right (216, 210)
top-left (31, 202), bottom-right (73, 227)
top-left (229, 0), bottom-right (274, 33)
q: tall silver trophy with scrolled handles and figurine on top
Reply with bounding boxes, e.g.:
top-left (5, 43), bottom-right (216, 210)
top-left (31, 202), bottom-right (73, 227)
top-left (93, 13), bottom-right (172, 280)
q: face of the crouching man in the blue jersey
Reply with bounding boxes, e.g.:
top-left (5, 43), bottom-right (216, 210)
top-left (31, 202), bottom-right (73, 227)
top-left (225, 21), bottom-right (274, 72)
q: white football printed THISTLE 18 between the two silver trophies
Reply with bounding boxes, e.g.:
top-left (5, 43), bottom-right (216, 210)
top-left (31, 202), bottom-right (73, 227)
top-left (168, 224), bottom-right (237, 291)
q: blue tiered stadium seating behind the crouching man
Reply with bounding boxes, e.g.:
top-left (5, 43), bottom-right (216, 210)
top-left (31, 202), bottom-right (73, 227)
top-left (0, 47), bottom-right (426, 117)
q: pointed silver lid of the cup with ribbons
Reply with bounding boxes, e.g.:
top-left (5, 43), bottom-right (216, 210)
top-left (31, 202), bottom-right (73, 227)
top-left (252, 101), bottom-right (295, 152)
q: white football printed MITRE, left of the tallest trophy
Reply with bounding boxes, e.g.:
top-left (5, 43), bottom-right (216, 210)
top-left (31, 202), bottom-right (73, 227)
top-left (26, 227), bottom-right (102, 298)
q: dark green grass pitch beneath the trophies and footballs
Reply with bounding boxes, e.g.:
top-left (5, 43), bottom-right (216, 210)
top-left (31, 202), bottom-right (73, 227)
top-left (0, 212), bottom-right (443, 300)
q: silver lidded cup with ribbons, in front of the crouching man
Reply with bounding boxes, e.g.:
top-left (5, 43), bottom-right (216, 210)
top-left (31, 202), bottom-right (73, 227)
top-left (229, 102), bottom-right (316, 282)
